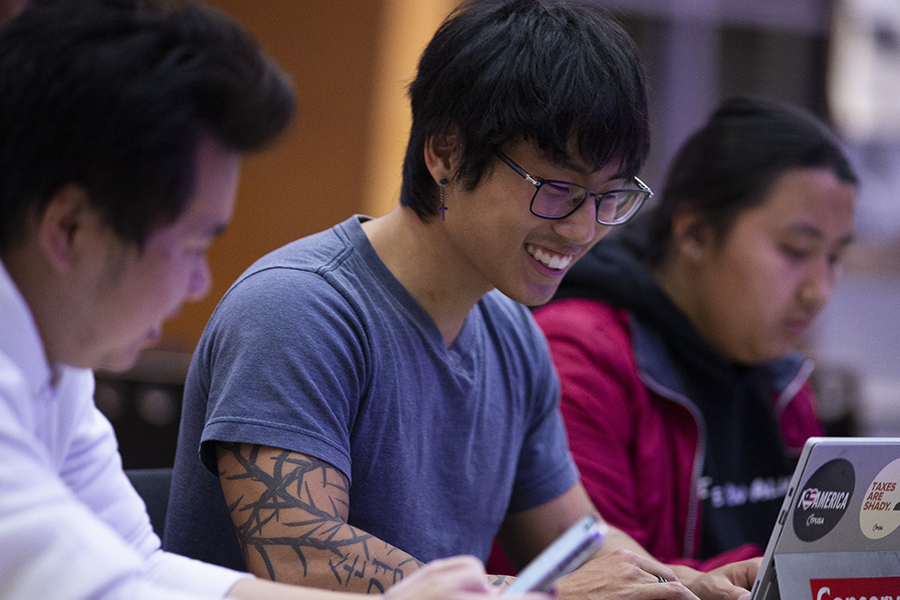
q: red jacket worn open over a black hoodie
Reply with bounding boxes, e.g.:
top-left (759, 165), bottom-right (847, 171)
top-left (535, 298), bottom-right (822, 570)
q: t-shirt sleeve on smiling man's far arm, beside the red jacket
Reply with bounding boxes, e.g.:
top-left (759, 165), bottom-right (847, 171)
top-left (509, 308), bottom-right (578, 513)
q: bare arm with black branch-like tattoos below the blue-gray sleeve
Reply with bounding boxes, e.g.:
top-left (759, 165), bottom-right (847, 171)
top-left (217, 443), bottom-right (422, 593)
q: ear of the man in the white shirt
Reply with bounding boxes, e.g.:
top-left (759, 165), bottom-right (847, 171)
top-left (37, 184), bottom-right (98, 271)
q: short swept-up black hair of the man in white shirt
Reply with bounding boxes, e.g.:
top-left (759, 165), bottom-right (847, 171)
top-left (0, 0), bottom-right (295, 251)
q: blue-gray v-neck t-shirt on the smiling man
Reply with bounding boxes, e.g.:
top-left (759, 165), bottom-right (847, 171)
top-left (165, 217), bottom-right (578, 568)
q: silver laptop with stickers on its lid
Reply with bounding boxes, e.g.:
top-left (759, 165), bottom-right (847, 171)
top-left (751, 438), bottom-right (900, 600)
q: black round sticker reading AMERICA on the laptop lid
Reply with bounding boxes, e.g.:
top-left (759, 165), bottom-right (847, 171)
top-left (794, 458), bottom-right (856, 542)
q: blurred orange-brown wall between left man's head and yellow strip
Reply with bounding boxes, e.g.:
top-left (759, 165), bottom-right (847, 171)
top-left (161, 0), bottom-right (382, 352)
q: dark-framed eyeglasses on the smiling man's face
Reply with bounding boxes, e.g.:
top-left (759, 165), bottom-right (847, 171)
top-left (495, 150), bottom-right (653, 225)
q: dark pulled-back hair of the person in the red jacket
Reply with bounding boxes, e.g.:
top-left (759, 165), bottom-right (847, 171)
top-left (635, 98), bottom-right (858, 265)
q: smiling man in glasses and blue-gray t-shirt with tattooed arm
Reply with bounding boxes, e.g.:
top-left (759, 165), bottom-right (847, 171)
top-left (165, 0), bottom-right (741, 598)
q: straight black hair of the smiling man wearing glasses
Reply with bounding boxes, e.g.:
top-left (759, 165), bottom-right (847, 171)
top-left (400, 0), bottom-right (650, 220)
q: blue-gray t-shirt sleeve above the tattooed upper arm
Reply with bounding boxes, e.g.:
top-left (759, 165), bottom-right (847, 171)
top-left (199, 268), bottom-right (369, 479)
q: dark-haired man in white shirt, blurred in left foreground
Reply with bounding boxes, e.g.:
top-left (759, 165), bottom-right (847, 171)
top-left (0, 0), bottom-right (542, 600)
